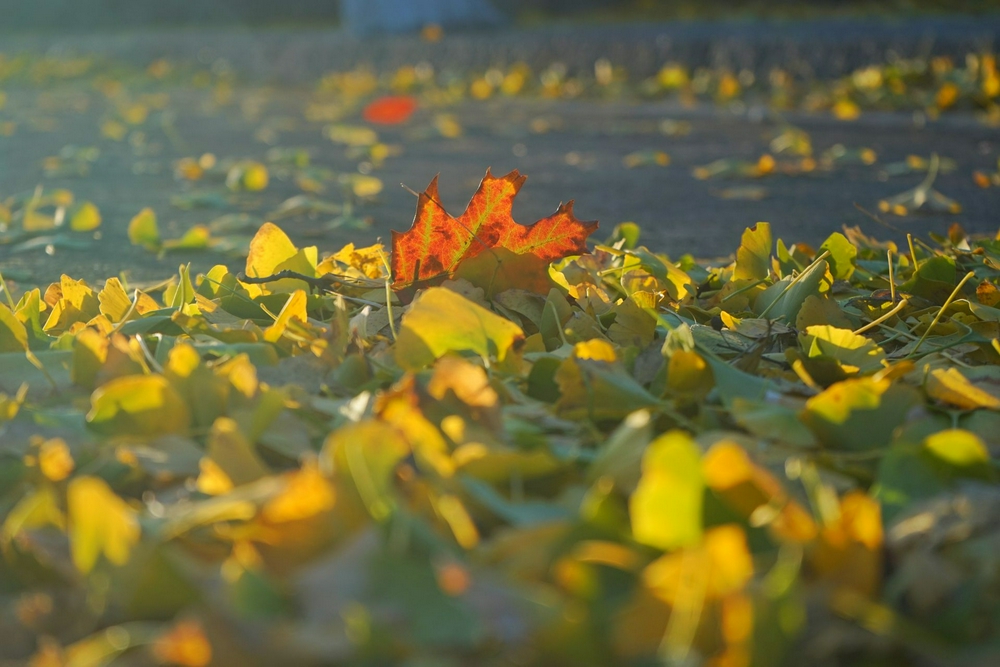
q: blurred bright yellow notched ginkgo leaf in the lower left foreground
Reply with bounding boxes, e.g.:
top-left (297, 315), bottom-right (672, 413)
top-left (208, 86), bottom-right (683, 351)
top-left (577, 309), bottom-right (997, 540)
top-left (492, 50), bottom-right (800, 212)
top-left (66, 477), bottom-right (141, 574)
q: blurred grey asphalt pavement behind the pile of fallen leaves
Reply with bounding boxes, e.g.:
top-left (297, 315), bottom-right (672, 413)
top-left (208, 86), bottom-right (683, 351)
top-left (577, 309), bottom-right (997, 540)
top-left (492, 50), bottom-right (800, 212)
top-left (0, 20), bottom-right (1000, 284)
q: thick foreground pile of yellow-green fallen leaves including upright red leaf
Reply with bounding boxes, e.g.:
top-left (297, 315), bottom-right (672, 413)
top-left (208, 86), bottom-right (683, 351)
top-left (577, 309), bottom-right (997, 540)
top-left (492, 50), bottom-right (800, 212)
top-left (0, 172), bottom-right (1000, 667)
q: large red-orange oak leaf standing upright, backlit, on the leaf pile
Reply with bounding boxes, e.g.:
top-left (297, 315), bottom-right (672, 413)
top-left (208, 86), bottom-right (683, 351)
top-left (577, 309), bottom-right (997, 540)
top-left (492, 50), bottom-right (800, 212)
top-left (392, 170), bottom-right (597, 294)
